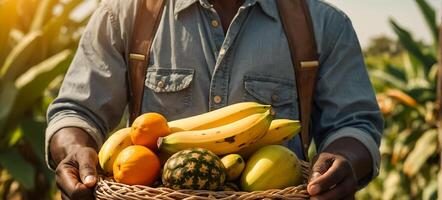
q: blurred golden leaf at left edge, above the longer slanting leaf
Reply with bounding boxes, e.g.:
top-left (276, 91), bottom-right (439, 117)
top-left (0, 31), bottom-right (42, 80)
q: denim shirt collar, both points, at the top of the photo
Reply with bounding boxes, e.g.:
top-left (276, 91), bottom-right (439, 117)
top-left (174, 0), bottom-right (278, 20)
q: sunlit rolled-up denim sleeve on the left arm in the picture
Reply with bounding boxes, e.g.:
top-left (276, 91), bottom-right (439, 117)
top-left (45, 2), bottom-right (127, 169)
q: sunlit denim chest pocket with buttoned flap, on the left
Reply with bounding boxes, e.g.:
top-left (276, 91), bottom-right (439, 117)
top-left (143, 68), bottom-right (195, 119)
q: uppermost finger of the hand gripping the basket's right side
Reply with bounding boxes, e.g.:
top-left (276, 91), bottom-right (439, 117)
top-left (309, 159), bottom-right (351, 191)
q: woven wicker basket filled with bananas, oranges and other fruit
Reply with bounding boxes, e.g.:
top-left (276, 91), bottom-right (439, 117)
top-left (95, 102), bottom-right (310, 200)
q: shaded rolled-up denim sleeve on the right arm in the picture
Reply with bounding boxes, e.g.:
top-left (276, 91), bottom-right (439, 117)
top-left (311, 17), bottom-right (384, 187)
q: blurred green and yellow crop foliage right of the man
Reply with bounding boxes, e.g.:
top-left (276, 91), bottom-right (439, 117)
top-left (358, 0), bottom-right (440, 199)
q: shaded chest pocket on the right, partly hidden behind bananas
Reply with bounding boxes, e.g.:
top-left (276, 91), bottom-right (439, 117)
top-left (244, 75), bottom-right (299, 119)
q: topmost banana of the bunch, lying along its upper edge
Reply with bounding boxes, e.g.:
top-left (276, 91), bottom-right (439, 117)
top-left (168, 102), bottom-right (270, 133)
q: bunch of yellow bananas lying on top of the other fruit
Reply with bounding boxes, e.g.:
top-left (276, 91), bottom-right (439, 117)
top-left (158, 102), bottom-right (301, 157)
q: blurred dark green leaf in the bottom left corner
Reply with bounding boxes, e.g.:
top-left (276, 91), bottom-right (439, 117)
top-left (0, 151), bottom-right (36, 189)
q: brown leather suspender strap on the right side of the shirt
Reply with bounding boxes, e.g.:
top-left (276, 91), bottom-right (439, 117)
top-left (276, 0), bottom-right (319, 159)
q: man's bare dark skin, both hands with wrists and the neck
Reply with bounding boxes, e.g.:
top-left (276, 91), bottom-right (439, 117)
top-left (50, 0), bottom-right (372, 200)
